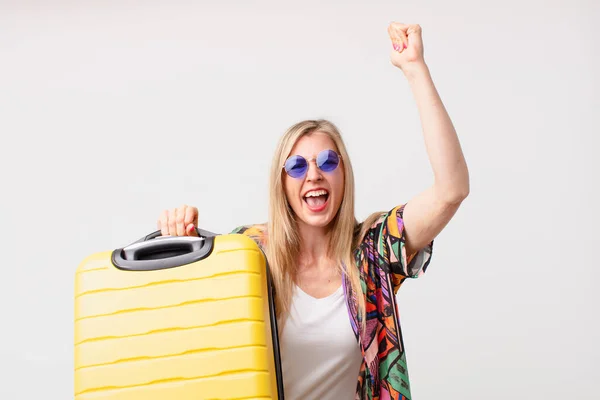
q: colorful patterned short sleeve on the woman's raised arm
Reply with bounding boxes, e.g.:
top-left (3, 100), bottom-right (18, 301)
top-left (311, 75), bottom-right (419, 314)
top-left (371, 204), bottom-right (433, 292)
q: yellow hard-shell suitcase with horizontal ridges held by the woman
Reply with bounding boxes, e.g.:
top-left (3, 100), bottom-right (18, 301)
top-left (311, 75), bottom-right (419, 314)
top-left (74, 230), bottom-right (283, 400)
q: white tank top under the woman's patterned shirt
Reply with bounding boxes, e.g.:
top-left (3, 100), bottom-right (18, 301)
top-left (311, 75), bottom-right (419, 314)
top-left (279, 286), bottom-right (362, 400)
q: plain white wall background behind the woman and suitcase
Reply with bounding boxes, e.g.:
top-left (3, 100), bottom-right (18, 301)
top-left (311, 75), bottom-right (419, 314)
top-left (0, 0), bottom-right (600, 400)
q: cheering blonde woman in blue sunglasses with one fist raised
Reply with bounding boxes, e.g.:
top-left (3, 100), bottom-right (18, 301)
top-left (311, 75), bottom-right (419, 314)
top-left (158, 23), bottom-right (469, 400)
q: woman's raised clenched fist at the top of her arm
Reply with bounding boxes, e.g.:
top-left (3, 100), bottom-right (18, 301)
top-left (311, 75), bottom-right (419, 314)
top-left (388, 22), bottom-right (425, 73)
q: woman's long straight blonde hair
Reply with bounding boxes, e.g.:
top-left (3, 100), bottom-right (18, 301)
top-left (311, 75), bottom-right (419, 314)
top-left (265, 120), bottom-right (379, 328)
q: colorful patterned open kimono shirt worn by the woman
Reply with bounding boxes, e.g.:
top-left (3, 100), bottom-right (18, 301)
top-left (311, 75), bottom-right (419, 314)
top-left (233, 205), bottom-right (433, 400)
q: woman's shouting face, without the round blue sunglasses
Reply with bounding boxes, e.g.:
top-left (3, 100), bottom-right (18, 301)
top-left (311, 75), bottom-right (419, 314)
top-left (283, 132), bottom-right (344, 227)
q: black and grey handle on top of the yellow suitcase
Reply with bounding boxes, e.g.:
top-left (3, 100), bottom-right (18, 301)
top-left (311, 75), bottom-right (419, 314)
top-left (111, 228), bottom-right (217, 271)
